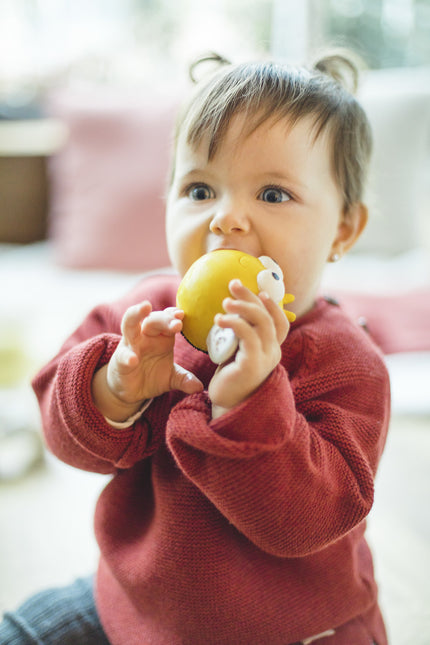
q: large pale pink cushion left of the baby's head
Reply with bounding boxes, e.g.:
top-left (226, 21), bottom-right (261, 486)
top-left (49, 89), bottom-right (177, 271)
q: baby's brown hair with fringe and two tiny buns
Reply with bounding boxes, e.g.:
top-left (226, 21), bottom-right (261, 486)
top-left (173, 52), bottom-right (372, 212)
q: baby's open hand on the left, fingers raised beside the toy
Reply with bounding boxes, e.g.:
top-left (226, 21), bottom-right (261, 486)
top-left (92, 301), bottom-right (203, 421)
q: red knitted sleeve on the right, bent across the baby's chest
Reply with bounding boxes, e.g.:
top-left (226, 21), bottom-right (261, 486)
top-left (167, 316), bottom-right (389, 557)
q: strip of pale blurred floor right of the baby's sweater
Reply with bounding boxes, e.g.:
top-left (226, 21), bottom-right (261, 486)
top-left (368, 416), bottom-right (430, 645)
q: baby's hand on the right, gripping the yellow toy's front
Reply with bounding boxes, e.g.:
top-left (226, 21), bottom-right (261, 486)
top-left (209, 280), bottom-right (290, 419)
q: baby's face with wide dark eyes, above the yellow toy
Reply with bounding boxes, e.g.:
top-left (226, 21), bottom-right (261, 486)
top-left (167, 114), bottom-right (343, 315)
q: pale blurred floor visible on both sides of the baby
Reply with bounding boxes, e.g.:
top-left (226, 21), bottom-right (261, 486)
top-left (0, 408), bottom-right (430, 645)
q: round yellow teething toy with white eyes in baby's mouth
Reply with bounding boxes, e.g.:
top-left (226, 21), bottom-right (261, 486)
top-left (176, 249), bottom-right (295, 363)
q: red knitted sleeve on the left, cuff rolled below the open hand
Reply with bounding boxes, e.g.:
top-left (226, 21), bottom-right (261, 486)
top-left (33, 278), bottom-right (176, 473)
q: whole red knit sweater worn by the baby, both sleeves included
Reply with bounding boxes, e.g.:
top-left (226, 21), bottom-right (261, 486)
top-left (34, 276), bottom-right (389, 645)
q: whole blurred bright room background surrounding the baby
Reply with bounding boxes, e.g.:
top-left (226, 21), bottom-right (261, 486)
top-left (0, 0), bottom-right (430, 645)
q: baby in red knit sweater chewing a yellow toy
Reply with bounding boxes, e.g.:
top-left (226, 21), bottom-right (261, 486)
top-left (0, 55), bottom-right (389, 645)
